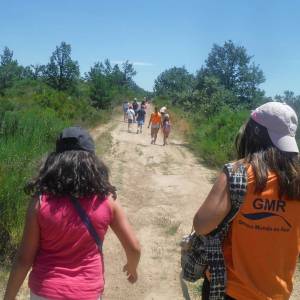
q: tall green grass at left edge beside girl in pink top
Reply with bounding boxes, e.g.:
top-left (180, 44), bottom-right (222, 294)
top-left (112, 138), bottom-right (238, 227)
top-left (0, 108), bottom-right (70, 259)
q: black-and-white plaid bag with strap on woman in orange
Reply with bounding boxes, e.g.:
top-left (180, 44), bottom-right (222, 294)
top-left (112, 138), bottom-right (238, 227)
top-left (181, 163), bottom-right (247, 300)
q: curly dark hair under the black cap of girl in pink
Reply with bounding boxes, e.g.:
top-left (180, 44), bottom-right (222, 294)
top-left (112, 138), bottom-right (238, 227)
top-left (25, 150), bottom-right (116, 198)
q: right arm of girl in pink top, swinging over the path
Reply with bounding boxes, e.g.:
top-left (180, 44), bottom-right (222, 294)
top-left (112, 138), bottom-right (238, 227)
top-left (110, 200), bottom-right (141, 283)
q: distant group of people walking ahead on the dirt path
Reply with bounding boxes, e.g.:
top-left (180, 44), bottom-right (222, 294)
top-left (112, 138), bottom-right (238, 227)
top-left (123, 98), bottom-right (171, 146)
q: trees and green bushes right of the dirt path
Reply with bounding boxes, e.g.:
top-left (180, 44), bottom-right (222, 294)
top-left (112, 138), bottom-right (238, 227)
top-left (154, 41), bottom-right (300, 167)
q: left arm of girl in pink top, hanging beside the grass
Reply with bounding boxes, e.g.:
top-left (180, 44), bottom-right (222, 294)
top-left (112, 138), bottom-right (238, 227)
top-left (4, 200), bottom-right (40, 300)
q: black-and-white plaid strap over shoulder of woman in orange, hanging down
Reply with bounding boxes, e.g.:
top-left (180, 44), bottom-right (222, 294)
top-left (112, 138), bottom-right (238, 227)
top-left (206, 163), bottom-right (247, 300)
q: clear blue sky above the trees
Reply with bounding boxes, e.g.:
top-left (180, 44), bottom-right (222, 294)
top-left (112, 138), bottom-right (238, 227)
top-left (0, 0), bottom-right (300, 96)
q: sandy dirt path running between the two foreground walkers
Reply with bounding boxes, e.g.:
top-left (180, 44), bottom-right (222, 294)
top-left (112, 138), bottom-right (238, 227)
top-left (97, 108), bottom-right (215, 300)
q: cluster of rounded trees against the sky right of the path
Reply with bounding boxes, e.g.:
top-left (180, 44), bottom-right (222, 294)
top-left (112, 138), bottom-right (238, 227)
top-left (154, 40), bottom-right (300, 116)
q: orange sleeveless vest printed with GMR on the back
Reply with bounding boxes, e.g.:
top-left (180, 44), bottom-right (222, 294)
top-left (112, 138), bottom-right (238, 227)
top-left (224, 167), bottom-right (300, 300)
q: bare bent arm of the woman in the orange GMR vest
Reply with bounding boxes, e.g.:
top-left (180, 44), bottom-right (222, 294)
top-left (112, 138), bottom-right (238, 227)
top-left (194, 172), bottom-right (231, 235)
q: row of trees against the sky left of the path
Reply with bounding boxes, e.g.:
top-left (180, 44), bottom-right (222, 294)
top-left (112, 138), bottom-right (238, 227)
top-left (0, 42), bottom-right (145, 109)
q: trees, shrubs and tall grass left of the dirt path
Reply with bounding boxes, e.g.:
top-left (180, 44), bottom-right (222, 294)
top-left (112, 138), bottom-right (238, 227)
top-left (0, 42), bottom-right (146, 264)
